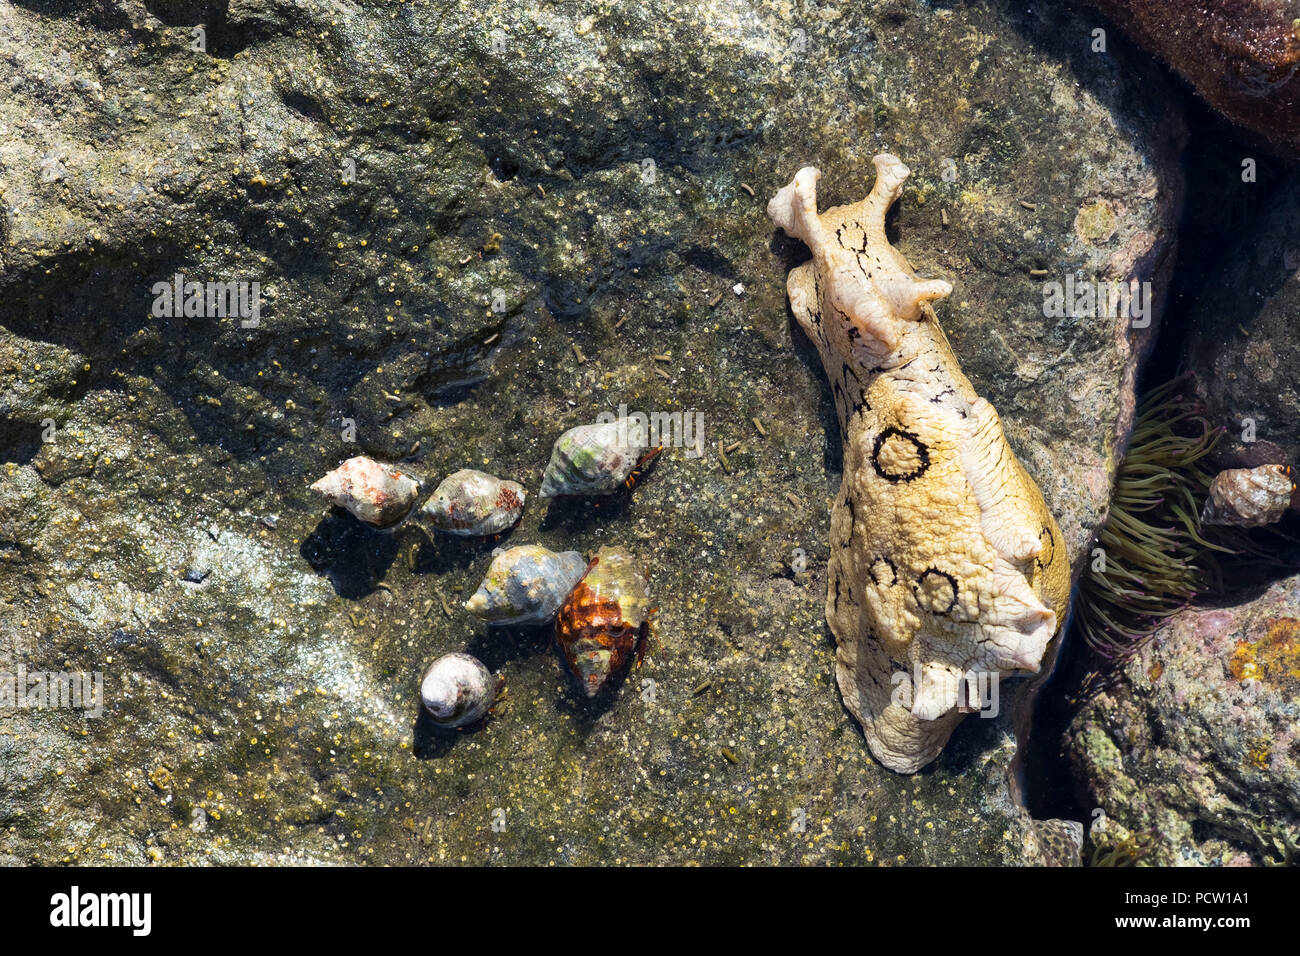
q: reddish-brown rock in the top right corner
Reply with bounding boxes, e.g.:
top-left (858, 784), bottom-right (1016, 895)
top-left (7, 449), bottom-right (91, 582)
top-left (1089, 0), bottom-right (1300, 156)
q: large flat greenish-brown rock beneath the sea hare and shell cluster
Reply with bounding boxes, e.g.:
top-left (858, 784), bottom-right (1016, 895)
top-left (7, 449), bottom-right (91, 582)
top-left (0, 0), bottom-right (1180, 864)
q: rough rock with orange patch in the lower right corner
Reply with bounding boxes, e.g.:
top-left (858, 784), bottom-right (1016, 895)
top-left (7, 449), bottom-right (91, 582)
top-left (1067, 578), bottom-right (1300, 866)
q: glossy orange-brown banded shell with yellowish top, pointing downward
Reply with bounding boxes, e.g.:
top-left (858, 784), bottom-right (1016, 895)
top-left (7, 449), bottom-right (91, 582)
top-left (555, 548), bottom-right (650, 697)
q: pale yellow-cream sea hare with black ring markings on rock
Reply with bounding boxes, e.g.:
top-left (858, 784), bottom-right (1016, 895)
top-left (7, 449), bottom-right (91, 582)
top-left (767, 155), bottom-right (1070, 773)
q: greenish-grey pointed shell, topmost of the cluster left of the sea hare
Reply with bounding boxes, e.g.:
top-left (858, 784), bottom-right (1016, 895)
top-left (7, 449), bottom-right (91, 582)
top-left (541, 418), bottom-right (650, 498)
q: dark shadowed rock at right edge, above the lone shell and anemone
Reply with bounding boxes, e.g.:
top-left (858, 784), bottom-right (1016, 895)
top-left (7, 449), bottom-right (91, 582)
top-left (1186, 174), bottom-right (1300, 481)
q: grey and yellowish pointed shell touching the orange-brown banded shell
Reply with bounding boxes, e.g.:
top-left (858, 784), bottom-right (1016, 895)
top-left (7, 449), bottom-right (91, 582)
top-left (465, 545), bottom-right (586, 624)
